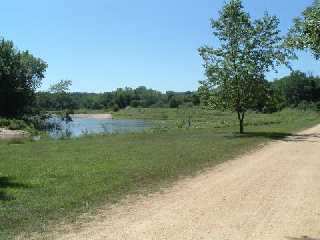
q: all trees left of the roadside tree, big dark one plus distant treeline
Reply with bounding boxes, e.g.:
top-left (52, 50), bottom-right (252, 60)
top-left (0, 36), bottom-right (200, 118)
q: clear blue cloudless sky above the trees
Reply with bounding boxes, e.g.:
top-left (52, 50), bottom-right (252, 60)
top-left (0, 0), bottom-right (320, 92)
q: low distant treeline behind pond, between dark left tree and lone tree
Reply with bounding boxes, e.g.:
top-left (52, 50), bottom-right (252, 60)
top-left (37, 87), bottom-right (200, 111)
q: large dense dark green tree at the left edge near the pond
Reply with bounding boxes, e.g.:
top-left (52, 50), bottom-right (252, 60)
top-left (0, 39), bottom-right (47, 117)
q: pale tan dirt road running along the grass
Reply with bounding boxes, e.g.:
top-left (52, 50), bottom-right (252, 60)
top-left (49, 126), bottom-right (320, 240)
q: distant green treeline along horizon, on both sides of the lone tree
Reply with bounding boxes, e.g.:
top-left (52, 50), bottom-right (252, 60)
top-left (37, 71), bottom-right (320, 113)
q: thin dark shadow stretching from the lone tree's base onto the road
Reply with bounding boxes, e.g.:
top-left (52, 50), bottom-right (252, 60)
top-left (226, 132), bottom-right (320, 142)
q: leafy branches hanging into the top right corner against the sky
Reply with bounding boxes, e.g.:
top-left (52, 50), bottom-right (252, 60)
top-left (286, 0), bottom-right (320, 59)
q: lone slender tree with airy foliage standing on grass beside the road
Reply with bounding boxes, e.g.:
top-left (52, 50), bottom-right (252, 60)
top-left (199, 0), bottom-right (293, 133)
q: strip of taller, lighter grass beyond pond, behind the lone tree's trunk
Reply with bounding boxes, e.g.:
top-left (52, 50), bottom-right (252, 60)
top-left (112, 108), bottom-right (317, 129)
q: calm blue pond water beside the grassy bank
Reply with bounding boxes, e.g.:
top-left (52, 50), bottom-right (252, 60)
top-left (49, 118), bottom-right (151, 138)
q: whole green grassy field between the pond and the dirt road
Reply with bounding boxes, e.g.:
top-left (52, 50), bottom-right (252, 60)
top-left (0, 109), bottom-right (320, 239)
